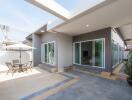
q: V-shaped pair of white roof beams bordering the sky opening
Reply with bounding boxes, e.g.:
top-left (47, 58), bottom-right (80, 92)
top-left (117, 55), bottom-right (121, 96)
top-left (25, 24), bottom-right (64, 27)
top-left (25, 0), bottom-right (108, 20)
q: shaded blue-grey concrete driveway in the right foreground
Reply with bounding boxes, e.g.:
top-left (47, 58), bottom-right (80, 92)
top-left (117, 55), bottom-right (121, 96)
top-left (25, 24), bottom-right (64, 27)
top-left (46, 72), bottom-right (132, 100)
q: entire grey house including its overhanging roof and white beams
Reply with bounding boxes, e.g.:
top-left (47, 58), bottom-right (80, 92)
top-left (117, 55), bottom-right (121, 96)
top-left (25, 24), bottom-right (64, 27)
top-left (26, 0), bottom-right (132, 73)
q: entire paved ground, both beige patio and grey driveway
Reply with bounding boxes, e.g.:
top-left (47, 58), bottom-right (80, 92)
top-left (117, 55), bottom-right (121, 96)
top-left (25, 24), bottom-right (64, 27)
top-left (0, 68), bottom-right (132, 100)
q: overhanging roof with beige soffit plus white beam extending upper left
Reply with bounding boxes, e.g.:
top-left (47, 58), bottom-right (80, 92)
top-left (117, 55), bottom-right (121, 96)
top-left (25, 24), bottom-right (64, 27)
top-left (26, 0), bottom-right (132, 36)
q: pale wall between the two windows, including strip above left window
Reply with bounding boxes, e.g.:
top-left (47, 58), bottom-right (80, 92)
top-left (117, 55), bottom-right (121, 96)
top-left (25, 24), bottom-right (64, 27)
top-left (41, 33), bottom-right (72, 71)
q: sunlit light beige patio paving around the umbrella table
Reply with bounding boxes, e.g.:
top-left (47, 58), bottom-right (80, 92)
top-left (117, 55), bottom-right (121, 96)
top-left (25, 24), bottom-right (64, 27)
top-left (0, 68), bottom-right (77, 100)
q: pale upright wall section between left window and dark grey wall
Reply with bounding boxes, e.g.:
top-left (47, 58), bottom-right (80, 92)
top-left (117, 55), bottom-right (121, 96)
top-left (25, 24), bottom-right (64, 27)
top-left (58, 35), bottom-right (73, 71)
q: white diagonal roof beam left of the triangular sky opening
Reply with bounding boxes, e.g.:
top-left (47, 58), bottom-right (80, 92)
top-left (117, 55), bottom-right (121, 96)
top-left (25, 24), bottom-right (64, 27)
top-left (26, 0), bottom-right (70, 20)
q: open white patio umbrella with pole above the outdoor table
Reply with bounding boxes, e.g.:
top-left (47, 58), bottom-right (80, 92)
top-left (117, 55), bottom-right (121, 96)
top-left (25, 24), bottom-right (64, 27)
top-left (5, 43), bottom-right (34, 63)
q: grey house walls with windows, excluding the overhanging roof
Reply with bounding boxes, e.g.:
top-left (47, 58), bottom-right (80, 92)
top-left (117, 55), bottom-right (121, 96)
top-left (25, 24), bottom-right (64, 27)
top-left (29, 26), bottom-right (125, 72)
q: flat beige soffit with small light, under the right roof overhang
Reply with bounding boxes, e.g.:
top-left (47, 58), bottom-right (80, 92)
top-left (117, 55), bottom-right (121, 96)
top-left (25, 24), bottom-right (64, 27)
top-left (54, 0), bottom-right (132, 36)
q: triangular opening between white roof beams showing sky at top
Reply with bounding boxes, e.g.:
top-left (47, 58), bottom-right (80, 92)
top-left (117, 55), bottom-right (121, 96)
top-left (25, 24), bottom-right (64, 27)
top-left (55, 0), bottom-right (106, 15)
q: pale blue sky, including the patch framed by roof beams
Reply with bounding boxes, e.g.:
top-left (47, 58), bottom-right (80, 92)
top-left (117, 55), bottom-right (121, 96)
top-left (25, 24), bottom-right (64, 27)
top-left (0, 0), bottom-right (102, 41)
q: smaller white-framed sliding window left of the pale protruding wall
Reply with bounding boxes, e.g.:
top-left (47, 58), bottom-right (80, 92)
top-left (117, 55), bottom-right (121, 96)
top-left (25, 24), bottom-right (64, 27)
top-left (41, 42), bottom-right (55, 65)
